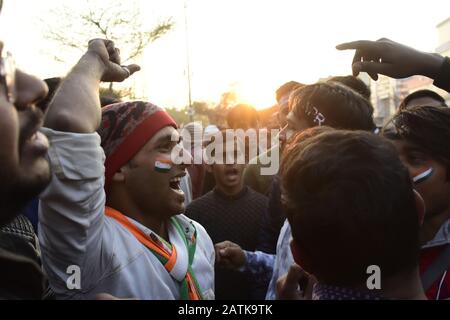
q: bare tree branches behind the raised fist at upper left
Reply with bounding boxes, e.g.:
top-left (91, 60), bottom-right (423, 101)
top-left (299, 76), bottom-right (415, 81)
top-left (40, 0), bottom-right (174, 96)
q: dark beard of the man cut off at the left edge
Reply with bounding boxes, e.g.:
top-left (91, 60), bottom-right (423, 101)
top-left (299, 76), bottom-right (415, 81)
top-left (0, 166), bottom-right (51, 227)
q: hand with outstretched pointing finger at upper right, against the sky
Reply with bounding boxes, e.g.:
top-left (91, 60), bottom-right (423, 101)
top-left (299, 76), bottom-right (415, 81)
top-left (336, 38), bottom-right (444, 85)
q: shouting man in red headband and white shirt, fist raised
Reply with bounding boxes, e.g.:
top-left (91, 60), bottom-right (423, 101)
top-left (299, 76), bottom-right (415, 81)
top-left (40, 40), bottom-right (214, 300)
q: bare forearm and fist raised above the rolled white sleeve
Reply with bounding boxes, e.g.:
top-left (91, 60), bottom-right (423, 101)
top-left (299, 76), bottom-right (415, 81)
top-left (44, 39), bottom-right (140, 133)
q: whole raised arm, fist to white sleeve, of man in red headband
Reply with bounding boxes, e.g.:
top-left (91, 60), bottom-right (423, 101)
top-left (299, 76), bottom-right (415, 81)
top-left (39, 40), bottom-right (139, 299)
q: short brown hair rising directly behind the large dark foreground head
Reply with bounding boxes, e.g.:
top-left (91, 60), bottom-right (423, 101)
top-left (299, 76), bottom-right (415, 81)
top-left (289, 82), bottom-right (375, 131)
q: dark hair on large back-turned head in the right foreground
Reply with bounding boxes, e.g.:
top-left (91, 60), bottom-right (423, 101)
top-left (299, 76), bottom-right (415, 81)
top-left (281, 130), bottom-right (420, 286)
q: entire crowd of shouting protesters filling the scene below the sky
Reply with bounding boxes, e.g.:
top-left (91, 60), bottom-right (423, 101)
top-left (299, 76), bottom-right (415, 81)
top-left (0, 1), bottom-right (450, 300)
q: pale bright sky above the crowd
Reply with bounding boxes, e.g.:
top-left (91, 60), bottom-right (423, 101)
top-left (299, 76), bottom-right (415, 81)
top-left (0, 0), bottom-right (450, 109)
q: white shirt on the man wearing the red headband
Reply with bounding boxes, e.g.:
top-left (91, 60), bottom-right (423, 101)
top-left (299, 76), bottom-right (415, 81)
top-left (39, 128), bottom-right (214, 300)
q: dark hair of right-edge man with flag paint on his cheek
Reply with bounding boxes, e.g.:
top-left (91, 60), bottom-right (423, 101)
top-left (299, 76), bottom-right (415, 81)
top-left (382, 106), bottom-right (450, 180)
